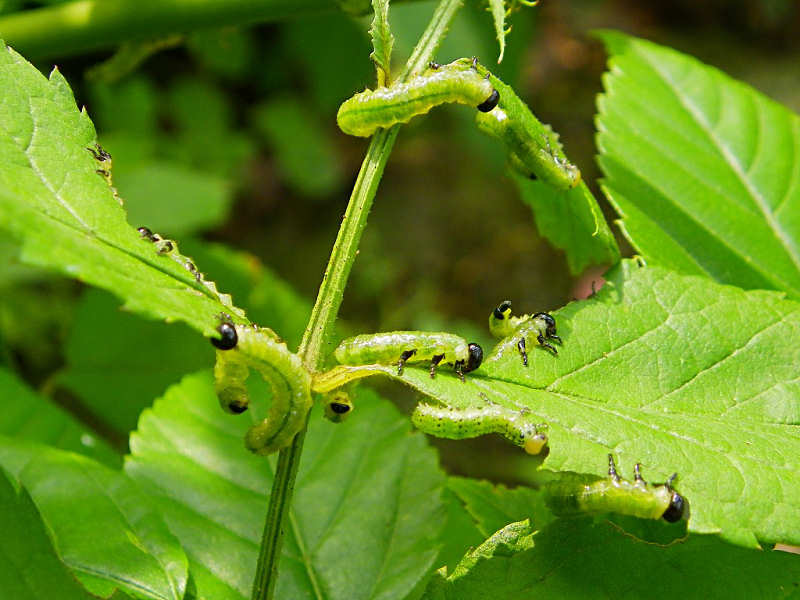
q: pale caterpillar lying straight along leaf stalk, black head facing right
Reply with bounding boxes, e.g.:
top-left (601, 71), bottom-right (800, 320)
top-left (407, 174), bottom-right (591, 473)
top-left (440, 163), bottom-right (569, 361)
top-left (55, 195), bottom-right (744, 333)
top-left (333, 331), bottom-right (483, 381)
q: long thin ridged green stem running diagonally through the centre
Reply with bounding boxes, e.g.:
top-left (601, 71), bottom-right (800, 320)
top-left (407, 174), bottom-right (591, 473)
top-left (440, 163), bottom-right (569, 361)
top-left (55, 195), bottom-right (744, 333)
top-left (251, 0), bottom-right (463, 600)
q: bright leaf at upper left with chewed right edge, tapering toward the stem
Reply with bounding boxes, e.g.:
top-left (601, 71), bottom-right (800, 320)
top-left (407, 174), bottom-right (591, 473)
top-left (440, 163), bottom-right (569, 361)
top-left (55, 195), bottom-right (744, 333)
top-left (0, 46), bottom-right (244, 336)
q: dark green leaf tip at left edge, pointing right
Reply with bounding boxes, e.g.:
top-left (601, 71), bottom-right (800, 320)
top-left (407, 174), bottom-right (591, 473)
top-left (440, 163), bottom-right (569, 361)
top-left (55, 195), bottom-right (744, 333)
top-left (0, 368), bottom-right (122, 467)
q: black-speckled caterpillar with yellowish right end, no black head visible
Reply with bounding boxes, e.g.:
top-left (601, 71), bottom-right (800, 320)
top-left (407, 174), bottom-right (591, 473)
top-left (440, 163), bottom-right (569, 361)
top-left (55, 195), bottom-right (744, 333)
top-left (411, 403), bottom-right (547, 454)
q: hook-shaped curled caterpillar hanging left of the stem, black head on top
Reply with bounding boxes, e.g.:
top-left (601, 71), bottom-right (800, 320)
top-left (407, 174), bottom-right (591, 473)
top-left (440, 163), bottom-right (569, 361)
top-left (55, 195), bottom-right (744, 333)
top-left (211, 321), bottom-right (312, 454)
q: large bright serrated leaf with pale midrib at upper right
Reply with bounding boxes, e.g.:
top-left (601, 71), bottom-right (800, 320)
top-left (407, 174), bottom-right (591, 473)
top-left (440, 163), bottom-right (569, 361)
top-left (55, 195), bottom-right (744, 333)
top-left (597, 32), bottom-right (800, 299)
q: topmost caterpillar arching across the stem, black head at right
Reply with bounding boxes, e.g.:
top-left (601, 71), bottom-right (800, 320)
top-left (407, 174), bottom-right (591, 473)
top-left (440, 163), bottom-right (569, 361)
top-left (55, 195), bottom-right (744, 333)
top-left (336, 58), bottom-right (499, 137)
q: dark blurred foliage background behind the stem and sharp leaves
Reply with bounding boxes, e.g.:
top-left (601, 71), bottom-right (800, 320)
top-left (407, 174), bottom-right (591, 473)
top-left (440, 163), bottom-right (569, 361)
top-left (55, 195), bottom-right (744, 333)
top-left (0, 0), bottom-right (800, 480)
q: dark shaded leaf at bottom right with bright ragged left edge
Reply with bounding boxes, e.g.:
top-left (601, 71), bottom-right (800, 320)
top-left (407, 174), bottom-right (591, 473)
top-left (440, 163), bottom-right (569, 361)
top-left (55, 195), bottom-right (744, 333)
top-left (424, 519), bottom-right (800, 600)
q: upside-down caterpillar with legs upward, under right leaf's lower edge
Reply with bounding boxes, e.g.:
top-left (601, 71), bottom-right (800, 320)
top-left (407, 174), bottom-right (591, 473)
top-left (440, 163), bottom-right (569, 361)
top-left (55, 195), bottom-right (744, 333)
top-left (545, 454), bottom-right (689, 523)
